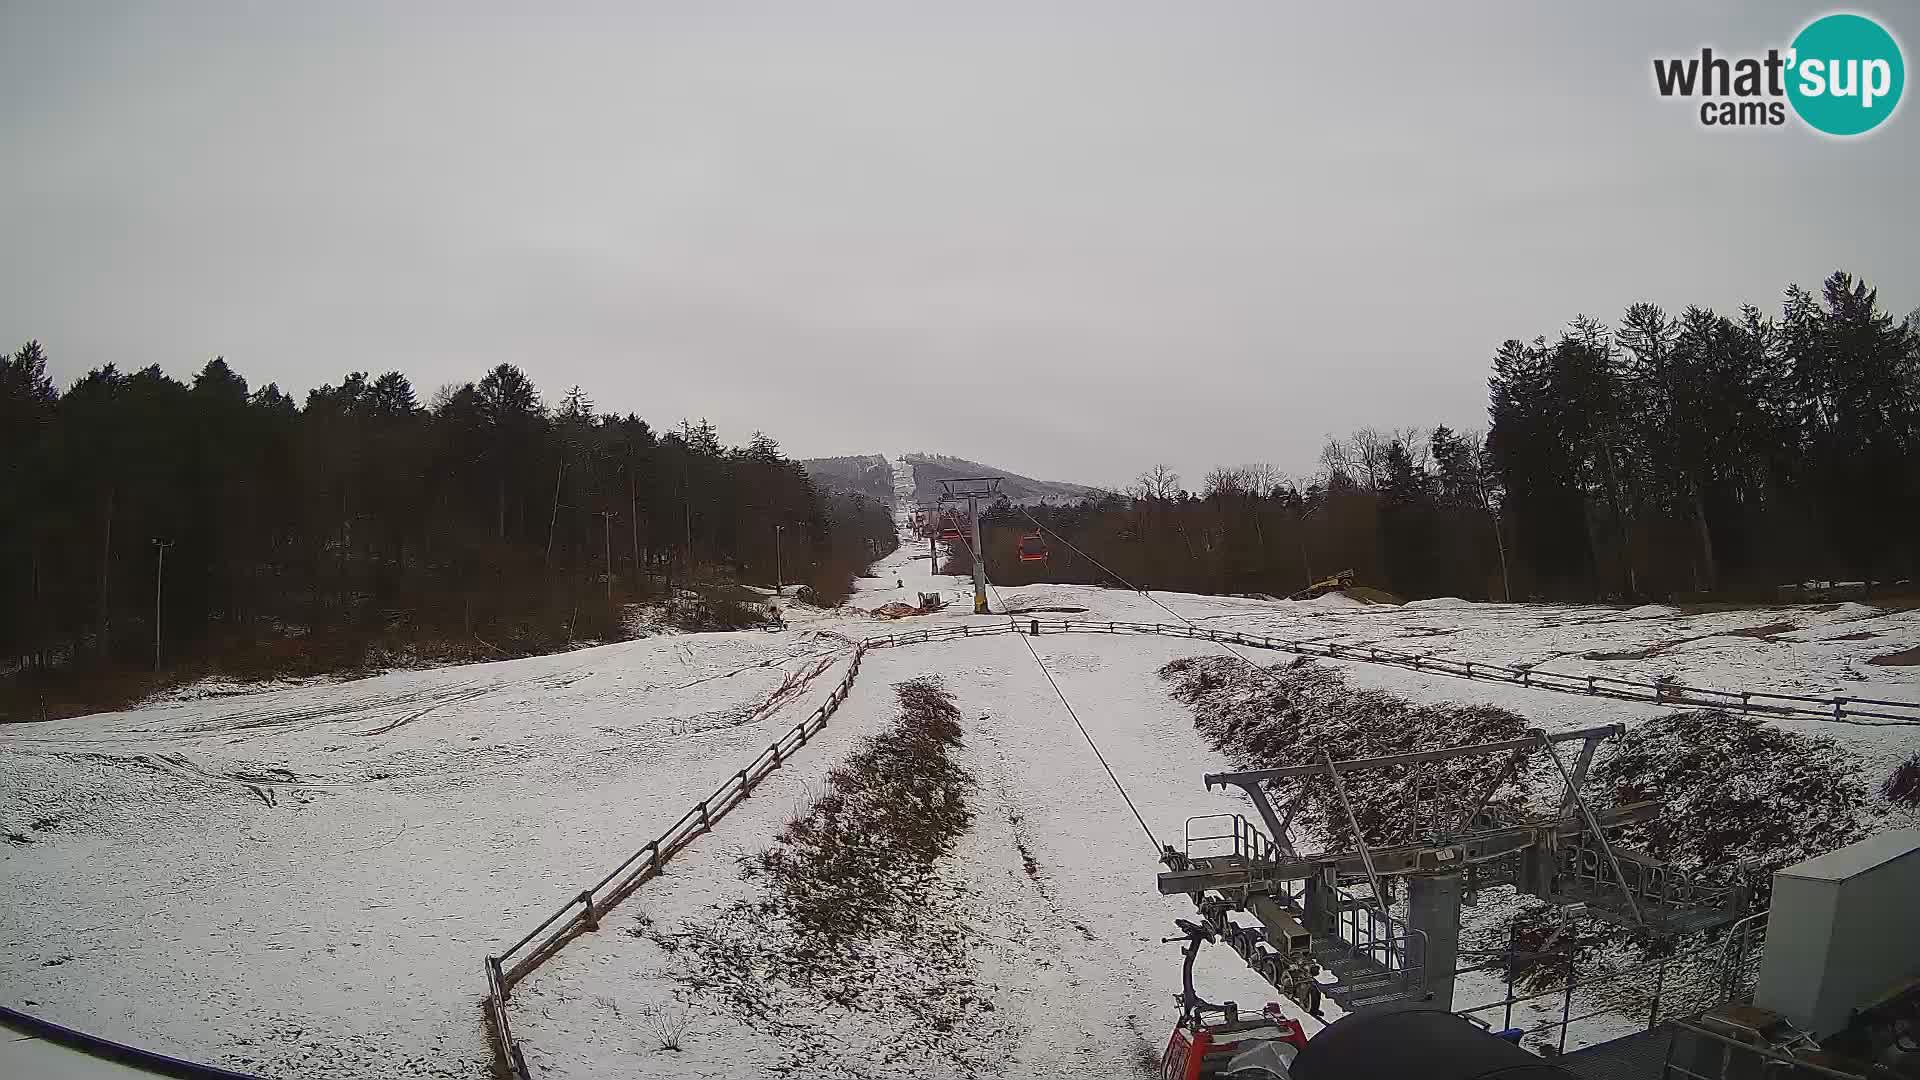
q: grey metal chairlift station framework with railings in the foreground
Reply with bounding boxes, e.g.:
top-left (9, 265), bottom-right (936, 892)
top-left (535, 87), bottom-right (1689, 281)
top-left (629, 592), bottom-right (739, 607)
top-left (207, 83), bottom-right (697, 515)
top-left (1160, 724), bottom-right (1751, 1011)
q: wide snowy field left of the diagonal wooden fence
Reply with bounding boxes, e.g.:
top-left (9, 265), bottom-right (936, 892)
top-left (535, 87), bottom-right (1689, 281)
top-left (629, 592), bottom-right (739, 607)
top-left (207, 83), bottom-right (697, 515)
top-left (0, 632), bottom-right (860, 1076)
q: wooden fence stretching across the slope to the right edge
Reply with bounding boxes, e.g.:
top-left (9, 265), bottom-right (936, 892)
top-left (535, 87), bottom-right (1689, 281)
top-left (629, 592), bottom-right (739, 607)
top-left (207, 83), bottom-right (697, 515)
top-left (866, 619), bottom-right (1920, 726)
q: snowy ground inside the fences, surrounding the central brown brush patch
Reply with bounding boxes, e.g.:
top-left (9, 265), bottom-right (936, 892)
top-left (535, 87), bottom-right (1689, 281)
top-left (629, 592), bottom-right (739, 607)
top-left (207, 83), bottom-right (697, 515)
top-left (513, 622), bottom-right (1305, 1078)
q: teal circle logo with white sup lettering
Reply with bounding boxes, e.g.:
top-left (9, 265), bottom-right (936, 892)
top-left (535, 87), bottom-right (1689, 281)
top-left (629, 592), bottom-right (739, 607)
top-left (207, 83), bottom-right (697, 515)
top-left (1788, 13), bottom-right (1907, 135)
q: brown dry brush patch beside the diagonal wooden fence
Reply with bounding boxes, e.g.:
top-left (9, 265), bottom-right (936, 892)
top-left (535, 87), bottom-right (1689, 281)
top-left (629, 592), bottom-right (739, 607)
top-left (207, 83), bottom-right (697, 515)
top-left (628, 678), bottom-right (1018, 1078)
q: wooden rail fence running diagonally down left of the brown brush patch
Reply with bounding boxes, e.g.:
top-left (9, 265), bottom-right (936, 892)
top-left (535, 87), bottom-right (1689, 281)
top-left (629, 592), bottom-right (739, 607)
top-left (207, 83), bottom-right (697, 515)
top-left (484, 644), bottom-right (872, 1080)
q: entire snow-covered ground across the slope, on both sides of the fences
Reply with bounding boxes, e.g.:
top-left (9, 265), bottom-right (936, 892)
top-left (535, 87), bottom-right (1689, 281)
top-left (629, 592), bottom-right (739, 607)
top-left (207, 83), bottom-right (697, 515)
top-left (0, 455), bottom-right (1920, 1078)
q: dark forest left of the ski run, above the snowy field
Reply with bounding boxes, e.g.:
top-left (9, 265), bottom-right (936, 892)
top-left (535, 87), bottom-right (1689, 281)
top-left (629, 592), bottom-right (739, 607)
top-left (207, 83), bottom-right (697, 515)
top-left (0, 342), bottom-right (893, 711)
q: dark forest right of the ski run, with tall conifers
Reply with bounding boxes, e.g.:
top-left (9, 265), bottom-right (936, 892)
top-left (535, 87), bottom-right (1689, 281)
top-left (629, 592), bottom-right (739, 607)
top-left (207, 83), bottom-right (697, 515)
top-left (983, 273), bottom-right (1920, 601)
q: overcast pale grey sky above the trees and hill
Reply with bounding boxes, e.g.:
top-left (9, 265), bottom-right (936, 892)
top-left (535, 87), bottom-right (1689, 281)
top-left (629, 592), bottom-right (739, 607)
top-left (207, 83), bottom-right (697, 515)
top-left (0, 0), bottom-right (1920, 484)
